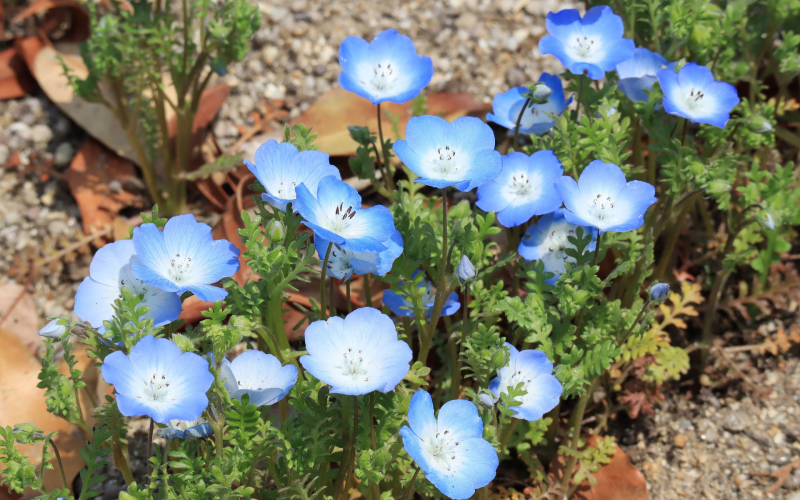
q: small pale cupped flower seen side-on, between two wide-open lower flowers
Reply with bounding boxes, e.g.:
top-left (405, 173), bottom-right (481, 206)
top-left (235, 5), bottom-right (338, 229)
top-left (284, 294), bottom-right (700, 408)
top-left (219, 350), bottom-right (297, 406)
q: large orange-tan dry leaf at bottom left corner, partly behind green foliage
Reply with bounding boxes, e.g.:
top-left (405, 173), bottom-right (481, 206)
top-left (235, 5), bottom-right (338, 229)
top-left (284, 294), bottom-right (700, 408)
top-left (0, 328), bottom-right (85, 498)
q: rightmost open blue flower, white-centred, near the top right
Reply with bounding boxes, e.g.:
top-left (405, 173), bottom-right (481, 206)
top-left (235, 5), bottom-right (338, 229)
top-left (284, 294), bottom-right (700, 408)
top-left (657, 63), bottom-right (739, 128)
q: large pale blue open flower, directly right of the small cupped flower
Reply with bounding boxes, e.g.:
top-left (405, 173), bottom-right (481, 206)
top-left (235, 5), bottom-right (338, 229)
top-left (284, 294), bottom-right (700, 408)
top-left (300, 307), bottom-right (411, 396)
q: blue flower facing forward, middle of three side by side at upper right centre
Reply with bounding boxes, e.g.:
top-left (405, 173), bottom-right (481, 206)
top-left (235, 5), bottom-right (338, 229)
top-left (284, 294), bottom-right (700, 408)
top-left (477, 150), bottom-right (564, 227)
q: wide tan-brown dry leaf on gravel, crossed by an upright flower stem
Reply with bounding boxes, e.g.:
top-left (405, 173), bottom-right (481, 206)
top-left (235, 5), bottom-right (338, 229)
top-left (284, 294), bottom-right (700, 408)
top-left (284, 89), bottom-right (491, 158)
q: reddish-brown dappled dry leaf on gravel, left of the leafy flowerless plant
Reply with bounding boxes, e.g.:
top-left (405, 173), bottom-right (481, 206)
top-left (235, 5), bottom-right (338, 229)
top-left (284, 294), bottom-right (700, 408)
top-left (65, 140), bottom-right (145, 240)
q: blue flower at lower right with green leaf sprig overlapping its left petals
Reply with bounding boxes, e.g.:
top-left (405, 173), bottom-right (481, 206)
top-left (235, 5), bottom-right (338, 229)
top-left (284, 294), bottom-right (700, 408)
top-left (489, 343), bottom-right (562, 422)
